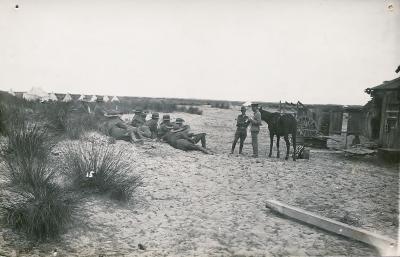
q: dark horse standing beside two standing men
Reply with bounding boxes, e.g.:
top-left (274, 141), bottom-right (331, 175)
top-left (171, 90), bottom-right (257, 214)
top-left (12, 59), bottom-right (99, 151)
top-left (259, 107), bottom-right (297, 161)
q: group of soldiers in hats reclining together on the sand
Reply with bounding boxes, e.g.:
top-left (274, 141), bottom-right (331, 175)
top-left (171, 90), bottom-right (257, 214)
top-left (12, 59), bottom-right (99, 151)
top-left (105, 110), bottom-right (212, 154)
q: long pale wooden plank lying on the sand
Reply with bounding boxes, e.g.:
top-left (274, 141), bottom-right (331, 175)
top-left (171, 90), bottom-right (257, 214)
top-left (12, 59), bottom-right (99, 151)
top-left (266, 200), bottom-right (399, 252)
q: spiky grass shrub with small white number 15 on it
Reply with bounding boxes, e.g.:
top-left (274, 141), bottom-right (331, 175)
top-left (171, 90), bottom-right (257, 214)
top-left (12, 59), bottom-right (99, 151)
top-left (65, 142), bottom-right (141, 201)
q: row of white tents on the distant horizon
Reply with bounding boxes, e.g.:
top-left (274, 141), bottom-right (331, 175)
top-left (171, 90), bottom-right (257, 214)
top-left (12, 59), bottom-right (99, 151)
top-left (8, 87), bottom-right (119, 102)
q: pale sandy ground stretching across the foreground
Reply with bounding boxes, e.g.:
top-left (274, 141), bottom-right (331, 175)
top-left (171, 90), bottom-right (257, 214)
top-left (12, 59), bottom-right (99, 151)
top-left (0, 107), bottom-right (399, 256)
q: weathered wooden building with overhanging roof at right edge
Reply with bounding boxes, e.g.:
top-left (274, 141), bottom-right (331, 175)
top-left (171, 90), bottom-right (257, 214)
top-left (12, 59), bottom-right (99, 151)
top-left (365, 78), bottom-right (400, 158)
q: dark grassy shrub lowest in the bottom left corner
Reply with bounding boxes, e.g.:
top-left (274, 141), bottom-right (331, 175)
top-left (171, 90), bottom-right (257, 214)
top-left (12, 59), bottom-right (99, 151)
top-left (2, 183), bottom-right (75, 240)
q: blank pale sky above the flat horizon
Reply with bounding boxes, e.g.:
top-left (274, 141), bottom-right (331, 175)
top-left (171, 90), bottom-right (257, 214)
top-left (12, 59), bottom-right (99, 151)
top-left (0, 0), bottom-right (400, 104)
